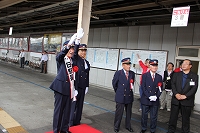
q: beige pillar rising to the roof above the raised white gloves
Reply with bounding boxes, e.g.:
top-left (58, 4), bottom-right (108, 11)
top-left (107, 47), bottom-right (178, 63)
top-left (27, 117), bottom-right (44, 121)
top-left (77, 0), bottom-right (92, 44)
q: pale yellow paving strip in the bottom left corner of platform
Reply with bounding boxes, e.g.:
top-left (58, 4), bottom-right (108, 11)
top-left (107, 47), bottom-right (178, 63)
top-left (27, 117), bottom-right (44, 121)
top-left (0, 108), bottom-right (28, 133)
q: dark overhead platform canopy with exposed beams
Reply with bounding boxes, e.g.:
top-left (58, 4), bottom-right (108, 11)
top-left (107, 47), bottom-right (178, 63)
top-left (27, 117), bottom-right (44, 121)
top-left (0, 0), bottom-right (200, 33)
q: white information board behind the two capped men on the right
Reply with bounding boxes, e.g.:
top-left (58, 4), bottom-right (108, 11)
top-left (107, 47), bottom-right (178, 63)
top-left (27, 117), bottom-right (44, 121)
top-left (118, 49), bottom-right (167, 75)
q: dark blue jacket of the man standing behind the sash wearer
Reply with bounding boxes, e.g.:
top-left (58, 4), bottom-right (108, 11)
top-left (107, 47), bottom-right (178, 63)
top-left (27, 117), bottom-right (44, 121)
top-left (72, 45), bottom-right (90, 89)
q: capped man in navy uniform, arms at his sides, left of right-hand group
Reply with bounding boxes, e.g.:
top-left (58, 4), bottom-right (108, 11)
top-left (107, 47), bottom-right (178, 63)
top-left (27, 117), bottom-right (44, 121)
top-left (112, 58), bottom-right (135, 132)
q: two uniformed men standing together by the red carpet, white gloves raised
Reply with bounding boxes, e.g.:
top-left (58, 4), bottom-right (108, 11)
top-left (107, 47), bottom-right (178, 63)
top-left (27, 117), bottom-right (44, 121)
top-left (50, 28), bottom-right (90, 133)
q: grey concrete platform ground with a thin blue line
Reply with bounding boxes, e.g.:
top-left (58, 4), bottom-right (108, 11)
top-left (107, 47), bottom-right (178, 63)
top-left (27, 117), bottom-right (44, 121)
top-left (0, 61), bottom-right (200, 133)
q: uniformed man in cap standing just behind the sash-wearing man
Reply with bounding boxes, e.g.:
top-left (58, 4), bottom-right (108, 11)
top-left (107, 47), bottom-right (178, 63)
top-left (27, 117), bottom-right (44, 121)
top-left (70, 44), bottom-right (90, 126)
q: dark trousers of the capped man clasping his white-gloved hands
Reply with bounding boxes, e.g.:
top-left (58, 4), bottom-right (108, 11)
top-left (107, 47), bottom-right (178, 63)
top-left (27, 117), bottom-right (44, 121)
top-left (141, 104), bottom-right (158, 132)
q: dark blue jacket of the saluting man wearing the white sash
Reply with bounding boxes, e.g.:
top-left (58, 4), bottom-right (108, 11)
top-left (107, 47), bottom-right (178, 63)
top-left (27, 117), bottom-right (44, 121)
top-left (49, 46), bottom-right (71, 95)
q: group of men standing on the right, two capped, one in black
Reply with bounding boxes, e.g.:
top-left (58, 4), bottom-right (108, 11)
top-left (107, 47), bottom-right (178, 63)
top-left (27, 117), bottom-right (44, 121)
top-left (112, 55), bottom-right (198, 133)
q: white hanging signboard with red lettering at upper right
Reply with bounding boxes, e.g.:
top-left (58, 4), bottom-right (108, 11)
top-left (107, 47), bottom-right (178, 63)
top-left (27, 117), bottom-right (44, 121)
top-left (171, 6), bottom-right (190, 27)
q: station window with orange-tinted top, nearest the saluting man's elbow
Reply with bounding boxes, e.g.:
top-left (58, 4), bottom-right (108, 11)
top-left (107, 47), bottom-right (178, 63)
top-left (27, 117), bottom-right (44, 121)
top-left (44, 33), bottom-right (62, 52)
